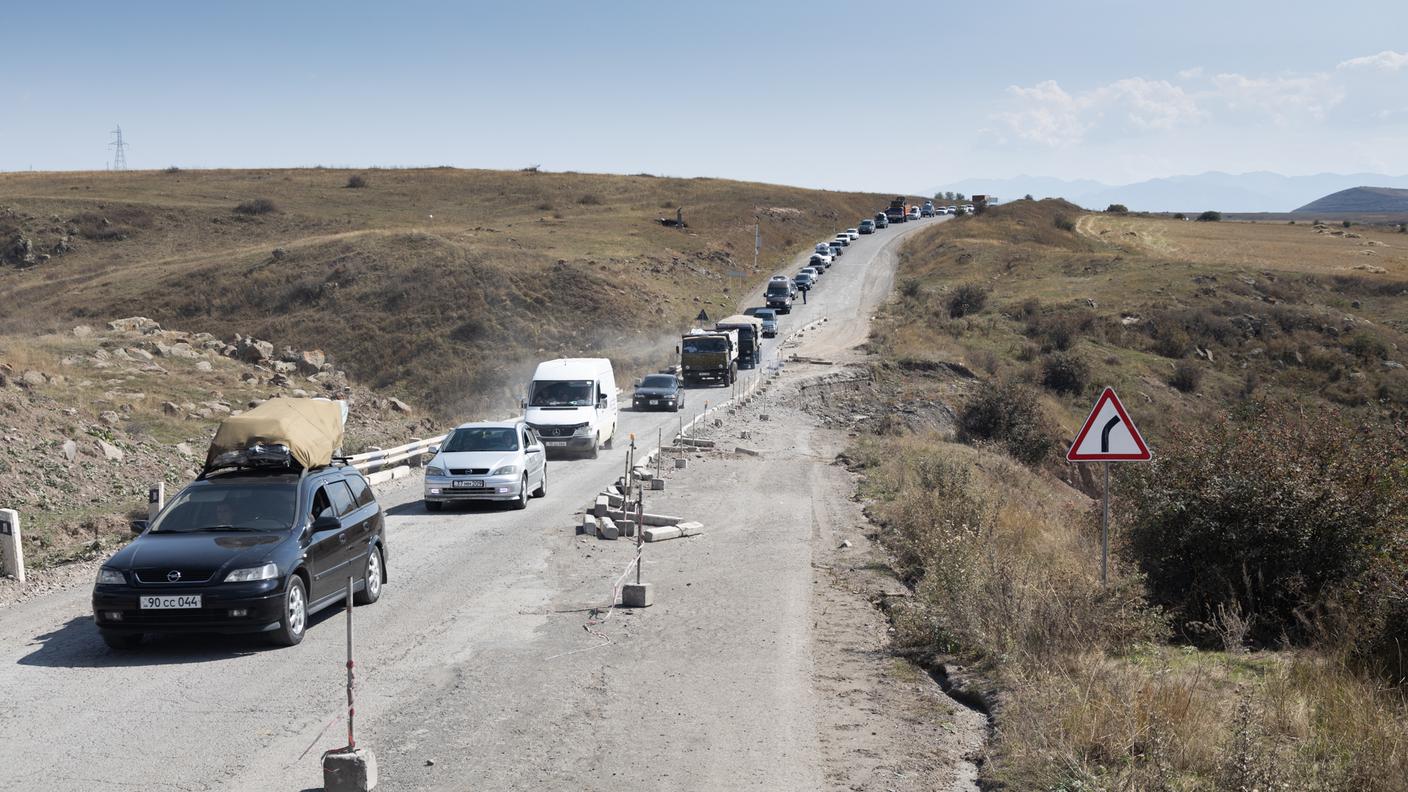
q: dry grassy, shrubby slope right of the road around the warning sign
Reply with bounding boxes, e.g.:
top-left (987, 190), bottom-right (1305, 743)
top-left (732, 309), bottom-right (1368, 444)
top-left (846, 200), bottom-right (1408, 792)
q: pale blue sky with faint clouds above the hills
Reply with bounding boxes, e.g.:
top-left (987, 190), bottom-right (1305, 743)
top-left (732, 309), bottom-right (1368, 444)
top-left (0, 0), bottom-right (1408, 192)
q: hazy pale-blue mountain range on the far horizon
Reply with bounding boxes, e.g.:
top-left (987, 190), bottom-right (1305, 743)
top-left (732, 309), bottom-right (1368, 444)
top-left (934, 171), bottom-right (1408, 211)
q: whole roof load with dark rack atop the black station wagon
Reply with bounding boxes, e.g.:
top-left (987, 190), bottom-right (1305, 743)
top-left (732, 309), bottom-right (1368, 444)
top-left (206, 399), bottom-right (346, 472)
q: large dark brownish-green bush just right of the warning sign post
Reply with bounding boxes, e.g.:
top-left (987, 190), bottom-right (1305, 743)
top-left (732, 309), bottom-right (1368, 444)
top-left (1118, 406), bottom-right (1408, 652)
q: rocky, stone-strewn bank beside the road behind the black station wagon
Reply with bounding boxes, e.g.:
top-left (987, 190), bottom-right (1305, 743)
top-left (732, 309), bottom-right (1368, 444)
top-left (0, 320), bottom-right (422, 583)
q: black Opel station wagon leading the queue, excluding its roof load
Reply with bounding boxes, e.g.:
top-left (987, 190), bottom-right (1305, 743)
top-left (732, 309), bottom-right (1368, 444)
top-left (93, 465), bottom-right (386, 648)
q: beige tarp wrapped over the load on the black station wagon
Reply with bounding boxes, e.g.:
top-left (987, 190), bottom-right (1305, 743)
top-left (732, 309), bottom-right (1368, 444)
top-left (206, 399), bottom-right (342, 468)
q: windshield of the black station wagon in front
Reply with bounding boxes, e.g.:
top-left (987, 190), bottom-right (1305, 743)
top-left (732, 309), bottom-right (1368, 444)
top-left (151, 481), bottom-right (297, 534)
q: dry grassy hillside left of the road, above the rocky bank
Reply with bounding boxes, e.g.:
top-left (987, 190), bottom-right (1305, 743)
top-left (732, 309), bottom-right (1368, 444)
top-left (0, 168), bottom-right (884, 414)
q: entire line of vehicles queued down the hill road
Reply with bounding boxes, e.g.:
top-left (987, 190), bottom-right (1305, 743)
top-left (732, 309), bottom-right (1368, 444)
top-left (92, 206), bottom-right (925, 650)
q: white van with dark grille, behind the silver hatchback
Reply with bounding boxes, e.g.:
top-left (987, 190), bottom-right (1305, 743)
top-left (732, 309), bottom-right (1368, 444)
top-left (524, 358), bottom-right (620, 458)
